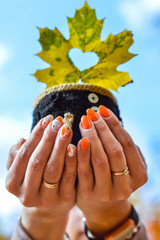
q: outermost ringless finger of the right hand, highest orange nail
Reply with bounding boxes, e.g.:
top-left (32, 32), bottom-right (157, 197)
top-left (99, 106), bottom-right (146, 188)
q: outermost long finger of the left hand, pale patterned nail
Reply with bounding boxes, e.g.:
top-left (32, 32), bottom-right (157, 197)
top-left (6, 115), bottom-right (53, 192)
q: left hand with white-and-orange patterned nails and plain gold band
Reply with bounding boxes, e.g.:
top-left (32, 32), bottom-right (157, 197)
top-left (6, 115), bottom-right (77, 239)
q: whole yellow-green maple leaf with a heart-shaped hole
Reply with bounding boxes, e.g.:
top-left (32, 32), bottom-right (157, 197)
top-left (34, 2), bottom-right (135, 91)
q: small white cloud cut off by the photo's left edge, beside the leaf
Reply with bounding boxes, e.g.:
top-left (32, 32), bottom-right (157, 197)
top-left (0, 43), bottom-right (11, 70)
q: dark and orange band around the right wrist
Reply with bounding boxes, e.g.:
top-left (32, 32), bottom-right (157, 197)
top-left (83, 206), bottom-right (140, 240)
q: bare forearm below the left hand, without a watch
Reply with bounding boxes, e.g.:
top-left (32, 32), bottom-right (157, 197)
top-left (12, 208), bottom-right (68, 240)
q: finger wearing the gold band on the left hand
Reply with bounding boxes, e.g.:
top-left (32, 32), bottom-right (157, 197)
top-left (41, 124), bottom-right (73, 200)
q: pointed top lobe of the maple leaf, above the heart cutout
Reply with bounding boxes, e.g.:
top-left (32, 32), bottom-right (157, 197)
top-left (68, 2), bottom-right (104, 52)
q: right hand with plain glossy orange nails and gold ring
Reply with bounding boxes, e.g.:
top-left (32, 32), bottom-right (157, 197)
top-left (77, 106), bottom-right (147, 235)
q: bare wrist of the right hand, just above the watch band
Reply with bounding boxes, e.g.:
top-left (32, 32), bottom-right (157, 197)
top-left (84, 200), bottom-right (132, 236)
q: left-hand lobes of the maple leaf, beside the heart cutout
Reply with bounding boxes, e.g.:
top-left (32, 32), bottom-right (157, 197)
top-left (34, 28), bottom-right (80, 88)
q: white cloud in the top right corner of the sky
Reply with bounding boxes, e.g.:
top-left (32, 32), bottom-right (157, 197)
top-left (120, 0), bottom-right (160, 30)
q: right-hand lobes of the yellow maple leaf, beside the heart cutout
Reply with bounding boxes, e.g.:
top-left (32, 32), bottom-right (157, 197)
top-left (81, 30), bottom-right (136, 91)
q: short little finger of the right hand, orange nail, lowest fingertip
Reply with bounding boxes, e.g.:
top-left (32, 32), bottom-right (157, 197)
top-left (78, 137), bottom-right (94, 193)
